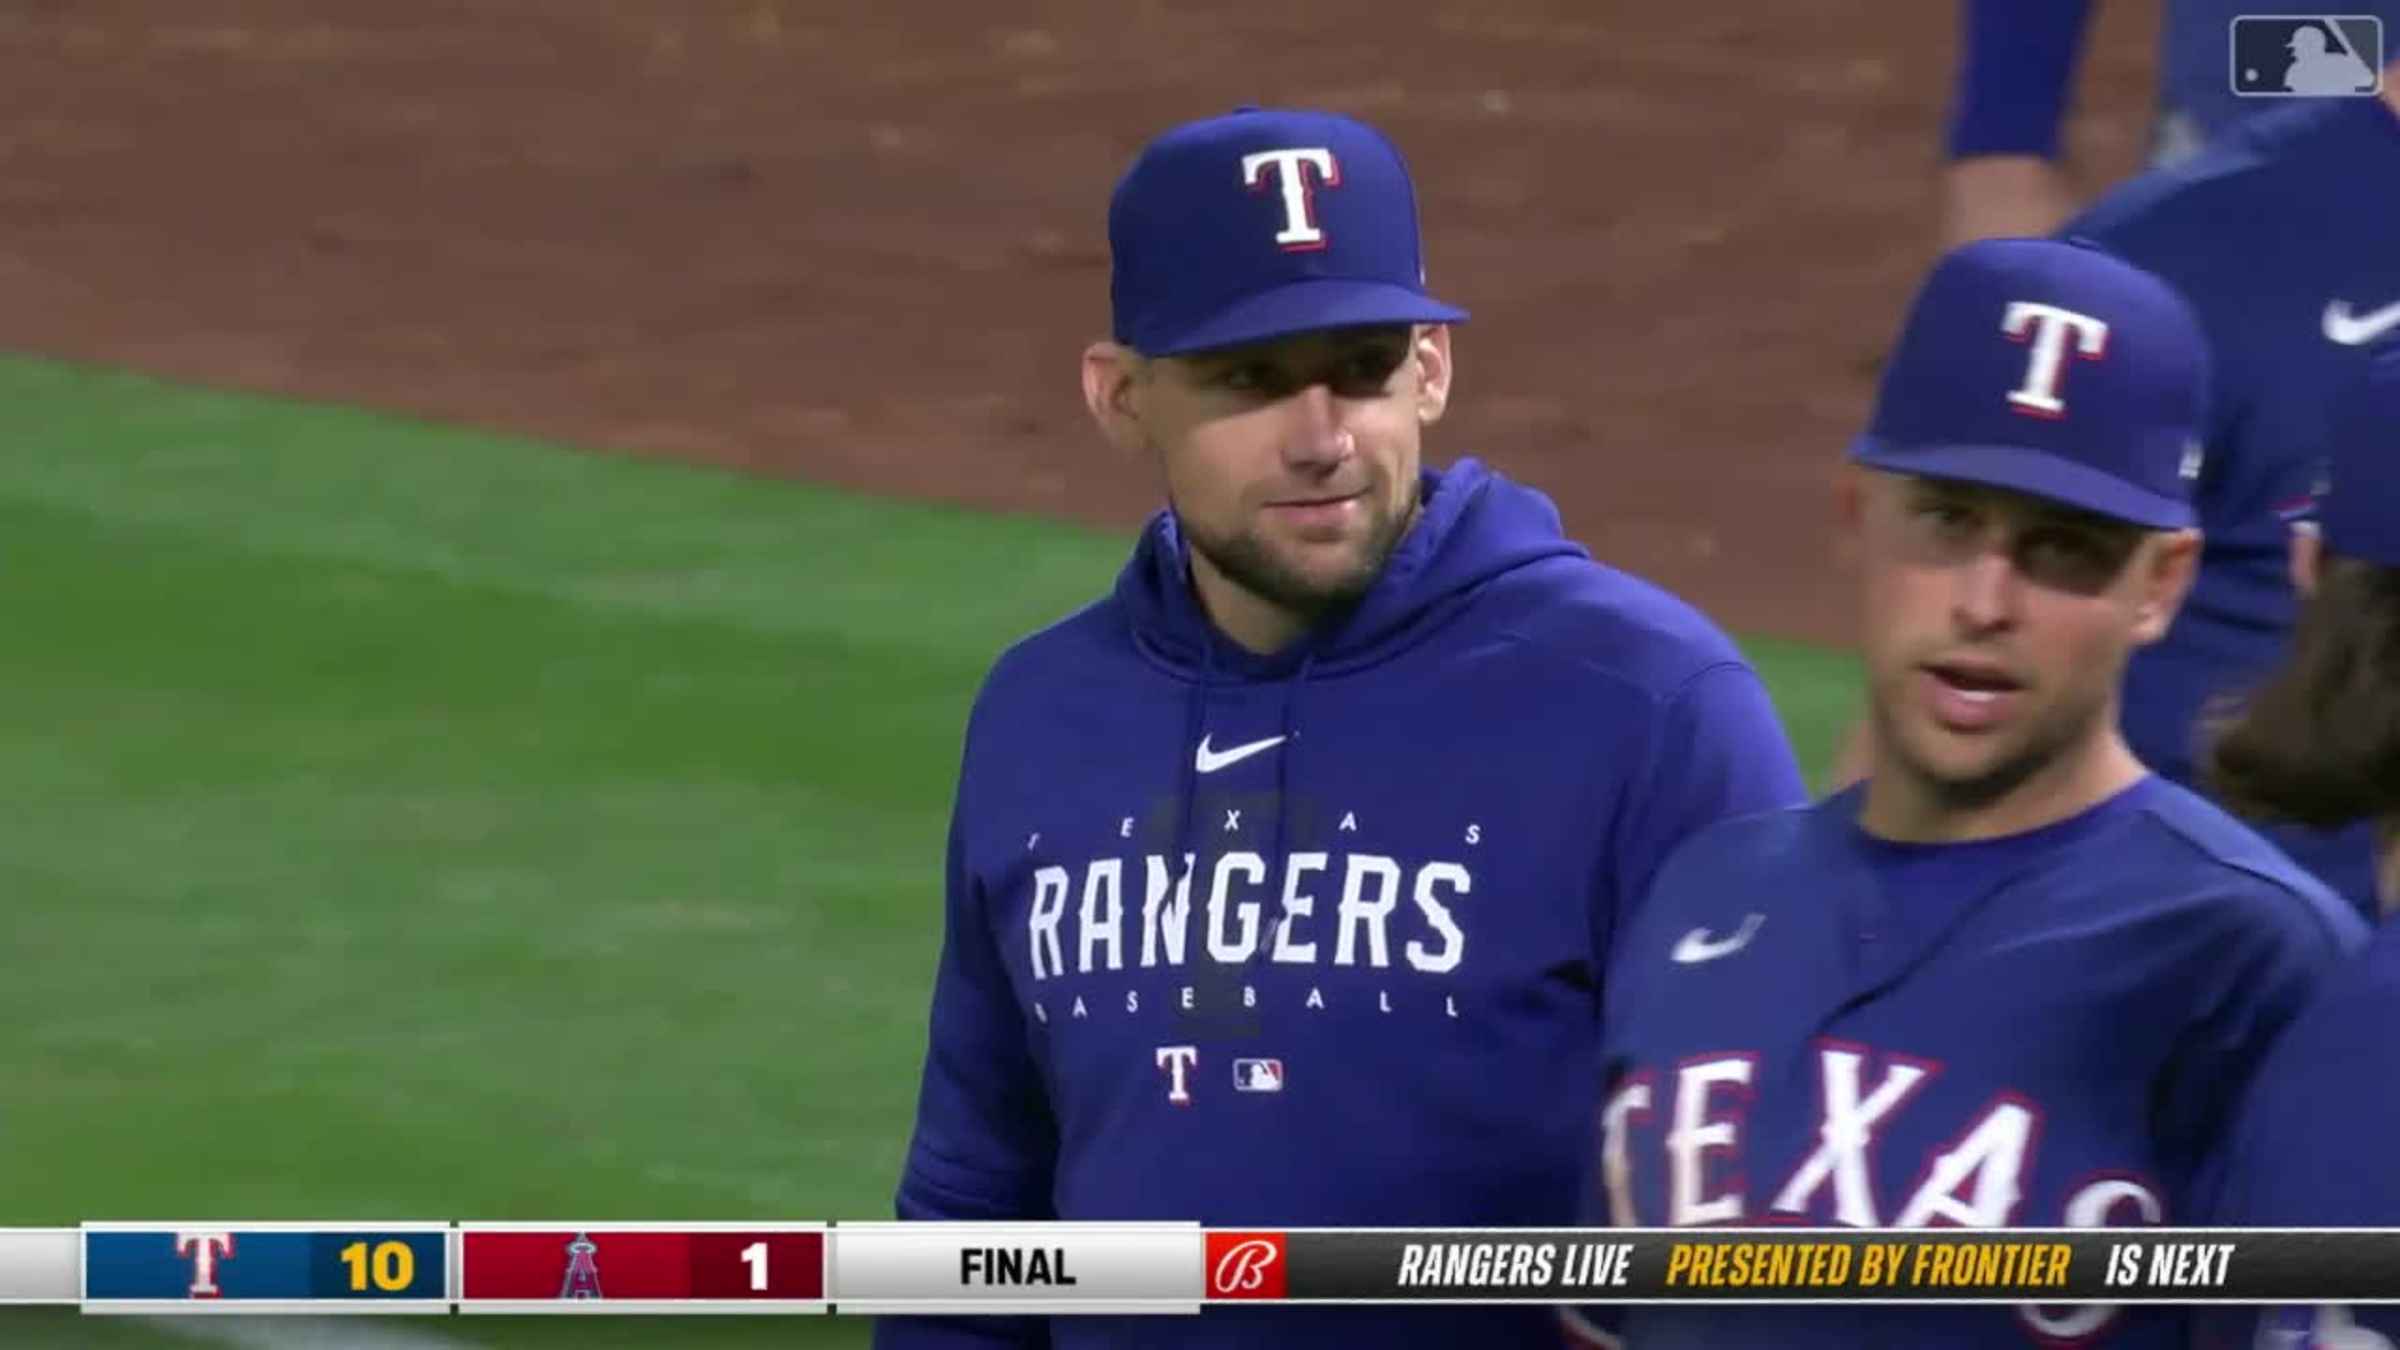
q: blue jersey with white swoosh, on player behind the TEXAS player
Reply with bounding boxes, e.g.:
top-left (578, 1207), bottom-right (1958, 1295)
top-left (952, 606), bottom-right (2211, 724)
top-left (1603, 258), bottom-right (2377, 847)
top-left (2066, 98), bottom-right (2400, 913)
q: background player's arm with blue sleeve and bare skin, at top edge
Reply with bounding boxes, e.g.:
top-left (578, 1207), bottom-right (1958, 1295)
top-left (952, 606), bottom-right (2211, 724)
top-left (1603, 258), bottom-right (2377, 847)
top-left (1942, 0), bottom-right (2090, 247)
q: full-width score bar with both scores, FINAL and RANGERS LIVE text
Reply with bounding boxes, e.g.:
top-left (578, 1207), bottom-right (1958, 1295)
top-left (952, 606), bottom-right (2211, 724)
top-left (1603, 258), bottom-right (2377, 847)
top-left (23, 1220), bottom-right (2400, 1306)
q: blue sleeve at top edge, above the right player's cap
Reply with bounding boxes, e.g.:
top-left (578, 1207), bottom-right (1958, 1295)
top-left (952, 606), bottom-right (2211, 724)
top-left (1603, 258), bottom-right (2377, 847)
top-left (1946, 0), bottom-right (2090, 159)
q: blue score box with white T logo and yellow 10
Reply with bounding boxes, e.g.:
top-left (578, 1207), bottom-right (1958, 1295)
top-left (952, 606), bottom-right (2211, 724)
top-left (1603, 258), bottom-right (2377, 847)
top-left (79, 1223), bottom-right (451, 1314)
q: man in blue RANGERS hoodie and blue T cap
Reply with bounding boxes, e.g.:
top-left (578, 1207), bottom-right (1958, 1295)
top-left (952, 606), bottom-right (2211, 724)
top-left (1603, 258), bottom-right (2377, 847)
top-left (876, 108), bottom-right (1805, 1350)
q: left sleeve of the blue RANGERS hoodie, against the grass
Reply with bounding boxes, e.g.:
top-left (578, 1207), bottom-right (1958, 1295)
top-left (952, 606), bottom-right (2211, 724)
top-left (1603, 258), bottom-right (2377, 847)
top-left (876, 730), bottom-right (1058, 1350)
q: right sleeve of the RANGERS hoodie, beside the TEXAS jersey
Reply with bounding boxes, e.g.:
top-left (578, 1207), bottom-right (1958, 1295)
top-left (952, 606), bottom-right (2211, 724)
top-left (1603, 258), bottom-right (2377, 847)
top-left (1596, 661), bottom-right (1807, 951)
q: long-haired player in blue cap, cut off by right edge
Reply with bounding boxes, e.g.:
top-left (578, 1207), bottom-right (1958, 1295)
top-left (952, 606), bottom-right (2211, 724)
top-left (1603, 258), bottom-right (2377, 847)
top-left (2208, 346), bottom-right (2400, 1350)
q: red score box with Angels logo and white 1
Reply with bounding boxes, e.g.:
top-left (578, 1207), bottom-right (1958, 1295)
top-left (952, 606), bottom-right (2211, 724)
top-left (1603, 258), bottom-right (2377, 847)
top-left (458, 1223), bottom-right (828, 1314)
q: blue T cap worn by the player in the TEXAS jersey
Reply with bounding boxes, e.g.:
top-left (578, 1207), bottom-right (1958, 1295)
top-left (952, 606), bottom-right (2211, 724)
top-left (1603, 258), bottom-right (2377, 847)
top-left (1850, 240), bottom-right (2208, 528)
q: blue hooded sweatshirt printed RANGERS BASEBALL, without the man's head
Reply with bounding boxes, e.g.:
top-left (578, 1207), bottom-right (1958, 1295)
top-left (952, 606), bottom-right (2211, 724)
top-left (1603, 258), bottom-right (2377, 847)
top-left (876, 459), bottom-right (1802, 1350)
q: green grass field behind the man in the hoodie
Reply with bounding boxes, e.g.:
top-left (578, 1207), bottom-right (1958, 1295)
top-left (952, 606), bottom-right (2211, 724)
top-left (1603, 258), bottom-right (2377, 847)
top-left (0, 360), bottom-right (1855, 1345)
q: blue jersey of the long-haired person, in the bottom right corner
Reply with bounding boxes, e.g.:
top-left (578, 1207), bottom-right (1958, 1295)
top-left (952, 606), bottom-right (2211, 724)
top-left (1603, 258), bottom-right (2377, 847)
top-left (2215, 927), bottom-right (2400, 1350)
